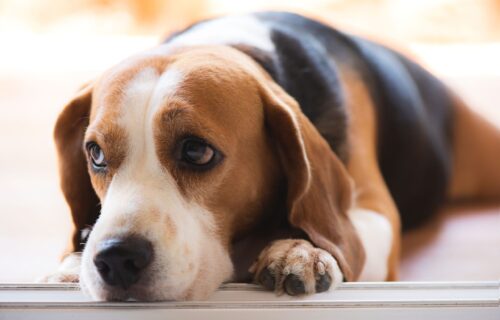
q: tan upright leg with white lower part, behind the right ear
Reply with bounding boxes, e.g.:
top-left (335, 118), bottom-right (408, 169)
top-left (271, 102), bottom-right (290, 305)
top-left (343, 72), bottom-right (401, 281)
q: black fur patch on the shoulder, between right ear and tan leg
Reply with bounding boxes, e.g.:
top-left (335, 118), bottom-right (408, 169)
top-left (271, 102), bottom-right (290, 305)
top-left (234, 13), bottom-right (348, 162)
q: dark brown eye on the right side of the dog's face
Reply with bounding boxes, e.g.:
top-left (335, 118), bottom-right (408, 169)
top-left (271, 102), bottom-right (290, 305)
top-left (181, 138), bottom-right (218, 167)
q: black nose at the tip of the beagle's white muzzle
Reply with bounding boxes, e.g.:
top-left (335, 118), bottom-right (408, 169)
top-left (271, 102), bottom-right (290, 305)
top-left (94, 237), bottom-right (153, 289)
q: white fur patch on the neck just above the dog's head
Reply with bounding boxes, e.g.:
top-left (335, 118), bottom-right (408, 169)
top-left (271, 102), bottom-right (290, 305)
top-left (166, 16), bottom-right (274, 52)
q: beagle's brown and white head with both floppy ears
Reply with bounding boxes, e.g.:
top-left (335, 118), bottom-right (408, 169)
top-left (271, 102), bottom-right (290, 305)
top-left (55, 46), bottom-right (362, 300)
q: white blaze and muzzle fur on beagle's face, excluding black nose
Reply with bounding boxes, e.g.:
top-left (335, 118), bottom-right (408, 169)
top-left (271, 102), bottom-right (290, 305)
top-left (81, 68), bottom-right (232, 300)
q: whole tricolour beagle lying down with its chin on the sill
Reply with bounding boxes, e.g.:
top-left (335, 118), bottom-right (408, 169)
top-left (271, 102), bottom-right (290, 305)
top-left (45, 12), bottom-right (500, 301)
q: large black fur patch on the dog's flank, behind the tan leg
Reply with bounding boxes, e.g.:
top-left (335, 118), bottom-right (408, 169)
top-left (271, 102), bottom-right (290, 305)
top-left (344, 38), bottom-right (452, 229)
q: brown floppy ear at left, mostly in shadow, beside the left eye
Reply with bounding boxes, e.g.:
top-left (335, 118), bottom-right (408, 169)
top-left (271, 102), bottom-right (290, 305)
top-left (54, 85), bottom-right (100, 253)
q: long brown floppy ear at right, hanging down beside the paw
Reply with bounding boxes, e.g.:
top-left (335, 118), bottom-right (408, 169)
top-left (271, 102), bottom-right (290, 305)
top-left (262, 79), bottom-right (365, 281)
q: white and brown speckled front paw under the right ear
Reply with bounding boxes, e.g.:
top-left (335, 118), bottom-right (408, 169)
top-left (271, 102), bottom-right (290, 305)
top-left (250, 239), bottom-right (343, 296)
